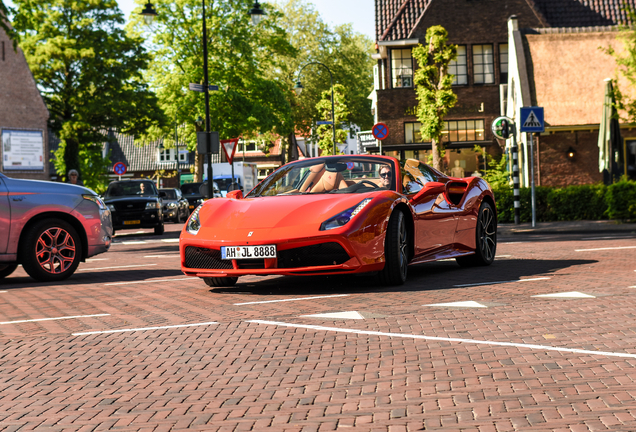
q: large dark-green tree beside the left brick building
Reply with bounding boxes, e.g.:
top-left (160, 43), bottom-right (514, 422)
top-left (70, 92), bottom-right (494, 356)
top-left (14, 0), bottom-right (164, 190)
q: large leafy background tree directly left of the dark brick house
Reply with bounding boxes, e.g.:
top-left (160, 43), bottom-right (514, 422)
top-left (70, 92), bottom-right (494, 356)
top-left (269, 0), bottom-right (375, 156)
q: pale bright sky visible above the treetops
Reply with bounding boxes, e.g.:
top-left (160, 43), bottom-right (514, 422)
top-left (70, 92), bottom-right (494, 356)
top-left (117, 0), bottom-right (375, 41)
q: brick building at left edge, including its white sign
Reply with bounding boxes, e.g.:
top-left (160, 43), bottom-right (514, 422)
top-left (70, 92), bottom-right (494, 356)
top-left (0, 29), bottom-right (50, 180)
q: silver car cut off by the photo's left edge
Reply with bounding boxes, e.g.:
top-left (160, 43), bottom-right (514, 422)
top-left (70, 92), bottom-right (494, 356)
top-left (0, 174), bottom-right (113, 281)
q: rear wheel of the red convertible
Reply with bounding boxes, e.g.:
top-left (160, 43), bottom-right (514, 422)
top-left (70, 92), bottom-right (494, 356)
top-left (455, 202), bottom-right (497, 267)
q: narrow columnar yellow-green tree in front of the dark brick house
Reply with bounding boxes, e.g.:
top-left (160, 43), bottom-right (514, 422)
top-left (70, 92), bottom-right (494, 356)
top-left (413, 26), bottom-right (457, 171)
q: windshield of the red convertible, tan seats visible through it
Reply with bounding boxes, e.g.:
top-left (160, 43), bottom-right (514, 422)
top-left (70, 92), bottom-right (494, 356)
top-left (247, 156), bottom-right (395, 197)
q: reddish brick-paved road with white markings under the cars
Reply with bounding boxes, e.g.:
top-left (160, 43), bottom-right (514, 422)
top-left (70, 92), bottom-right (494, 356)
top-left (0, 221), bottom-right (636, 432)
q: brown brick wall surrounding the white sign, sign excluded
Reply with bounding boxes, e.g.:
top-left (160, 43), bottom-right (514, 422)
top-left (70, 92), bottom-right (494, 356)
top-left (0, 29), bottom-right (50, 180)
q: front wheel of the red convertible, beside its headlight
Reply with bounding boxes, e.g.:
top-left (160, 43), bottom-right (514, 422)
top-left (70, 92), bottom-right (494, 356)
top-left (379, 211), bottom-right (409, 286)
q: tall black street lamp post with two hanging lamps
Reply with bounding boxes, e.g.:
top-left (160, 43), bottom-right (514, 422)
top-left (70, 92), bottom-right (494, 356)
top-left (141, 0), bottom-right (265, 198)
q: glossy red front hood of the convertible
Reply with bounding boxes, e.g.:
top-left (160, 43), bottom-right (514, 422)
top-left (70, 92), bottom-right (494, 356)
top-left (199, 193), bottom-right (377, 240)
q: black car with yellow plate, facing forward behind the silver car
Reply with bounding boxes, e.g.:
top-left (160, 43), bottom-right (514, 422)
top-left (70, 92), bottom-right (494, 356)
top-left (104, 180), bottom-right (164, 235)
